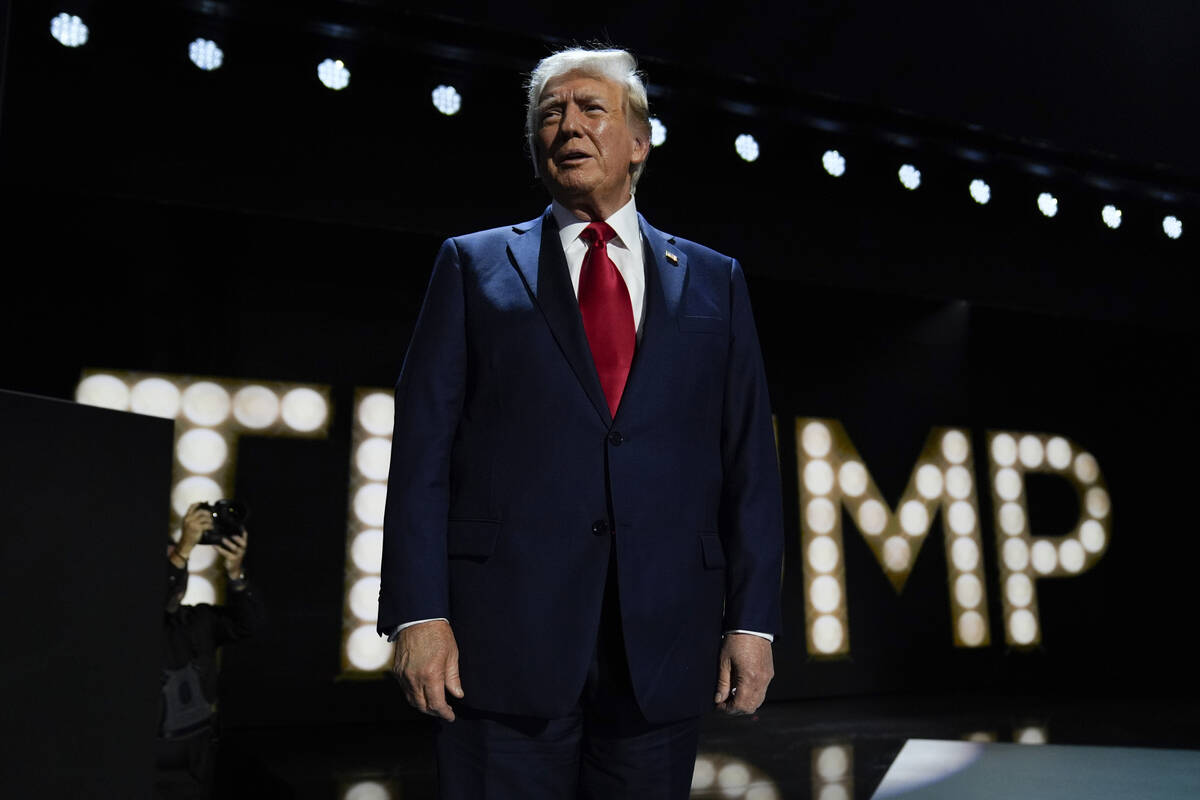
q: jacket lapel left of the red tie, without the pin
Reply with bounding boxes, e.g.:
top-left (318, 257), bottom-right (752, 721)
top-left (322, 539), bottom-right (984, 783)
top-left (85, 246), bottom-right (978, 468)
top-left (509, 209), bottom-right (612, 426)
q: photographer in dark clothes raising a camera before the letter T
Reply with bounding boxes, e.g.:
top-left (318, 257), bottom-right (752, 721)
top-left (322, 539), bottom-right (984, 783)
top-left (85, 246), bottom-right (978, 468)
top-left (155, 504), bottom-right (264, 798)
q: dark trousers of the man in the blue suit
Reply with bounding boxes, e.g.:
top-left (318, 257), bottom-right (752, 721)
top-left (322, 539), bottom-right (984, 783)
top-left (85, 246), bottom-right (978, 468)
top-left (436, 542), bottom-right (700, 800)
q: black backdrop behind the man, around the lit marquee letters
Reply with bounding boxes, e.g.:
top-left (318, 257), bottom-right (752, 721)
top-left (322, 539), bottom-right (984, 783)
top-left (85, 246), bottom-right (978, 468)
top-left (0, 4), bottom-right (1200, 722)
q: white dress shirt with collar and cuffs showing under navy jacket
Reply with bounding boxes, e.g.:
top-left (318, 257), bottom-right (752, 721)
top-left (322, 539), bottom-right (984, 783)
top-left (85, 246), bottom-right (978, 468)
top-left (388, 196), bottom-right (775, 642)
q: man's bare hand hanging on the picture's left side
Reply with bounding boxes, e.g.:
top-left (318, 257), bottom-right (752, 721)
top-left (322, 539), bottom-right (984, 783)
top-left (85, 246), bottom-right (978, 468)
top-left (391, 620), bottom-right (463, 722)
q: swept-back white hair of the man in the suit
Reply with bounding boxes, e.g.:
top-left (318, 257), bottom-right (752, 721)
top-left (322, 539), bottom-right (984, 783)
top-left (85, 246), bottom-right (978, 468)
top-left (526, 48), bottom-right (650, 188)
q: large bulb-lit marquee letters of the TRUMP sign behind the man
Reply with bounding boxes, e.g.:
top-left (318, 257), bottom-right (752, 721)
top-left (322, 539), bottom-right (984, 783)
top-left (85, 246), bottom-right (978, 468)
top-left (76, 369), bottom-right (1111, 676)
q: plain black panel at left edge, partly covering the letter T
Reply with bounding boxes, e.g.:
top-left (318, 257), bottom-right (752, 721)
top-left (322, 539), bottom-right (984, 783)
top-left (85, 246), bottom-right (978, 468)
top-left (0, 391), bottom-right (173, 800)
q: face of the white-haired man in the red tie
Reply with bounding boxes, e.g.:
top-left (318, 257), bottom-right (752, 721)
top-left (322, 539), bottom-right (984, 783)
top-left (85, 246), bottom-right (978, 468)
top-left (535, 72), bottom-right (649, 218)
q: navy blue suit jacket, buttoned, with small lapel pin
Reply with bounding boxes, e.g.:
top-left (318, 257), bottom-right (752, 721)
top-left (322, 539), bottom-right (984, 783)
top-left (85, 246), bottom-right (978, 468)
top-left (379, 210), bottom-right (782, 722)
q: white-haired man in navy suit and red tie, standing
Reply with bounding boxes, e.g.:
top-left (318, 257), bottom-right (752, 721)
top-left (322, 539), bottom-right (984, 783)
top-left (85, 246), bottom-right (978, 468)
top-left (379, 50), bottom-right (782, 800)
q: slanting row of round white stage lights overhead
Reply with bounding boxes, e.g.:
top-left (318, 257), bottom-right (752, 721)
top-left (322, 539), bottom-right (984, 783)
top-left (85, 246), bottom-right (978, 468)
top-left (50, 12), bottom-right (1183, 239)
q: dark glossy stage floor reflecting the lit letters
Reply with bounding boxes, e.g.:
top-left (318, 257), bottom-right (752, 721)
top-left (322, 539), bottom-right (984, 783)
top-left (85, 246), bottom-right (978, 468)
top-left (217, 696), bottom-right (1200, 800)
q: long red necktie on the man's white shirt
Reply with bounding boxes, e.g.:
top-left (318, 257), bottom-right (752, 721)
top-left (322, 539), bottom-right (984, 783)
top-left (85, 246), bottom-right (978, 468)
top-left (580, 222), bottom-right (636, 416)
